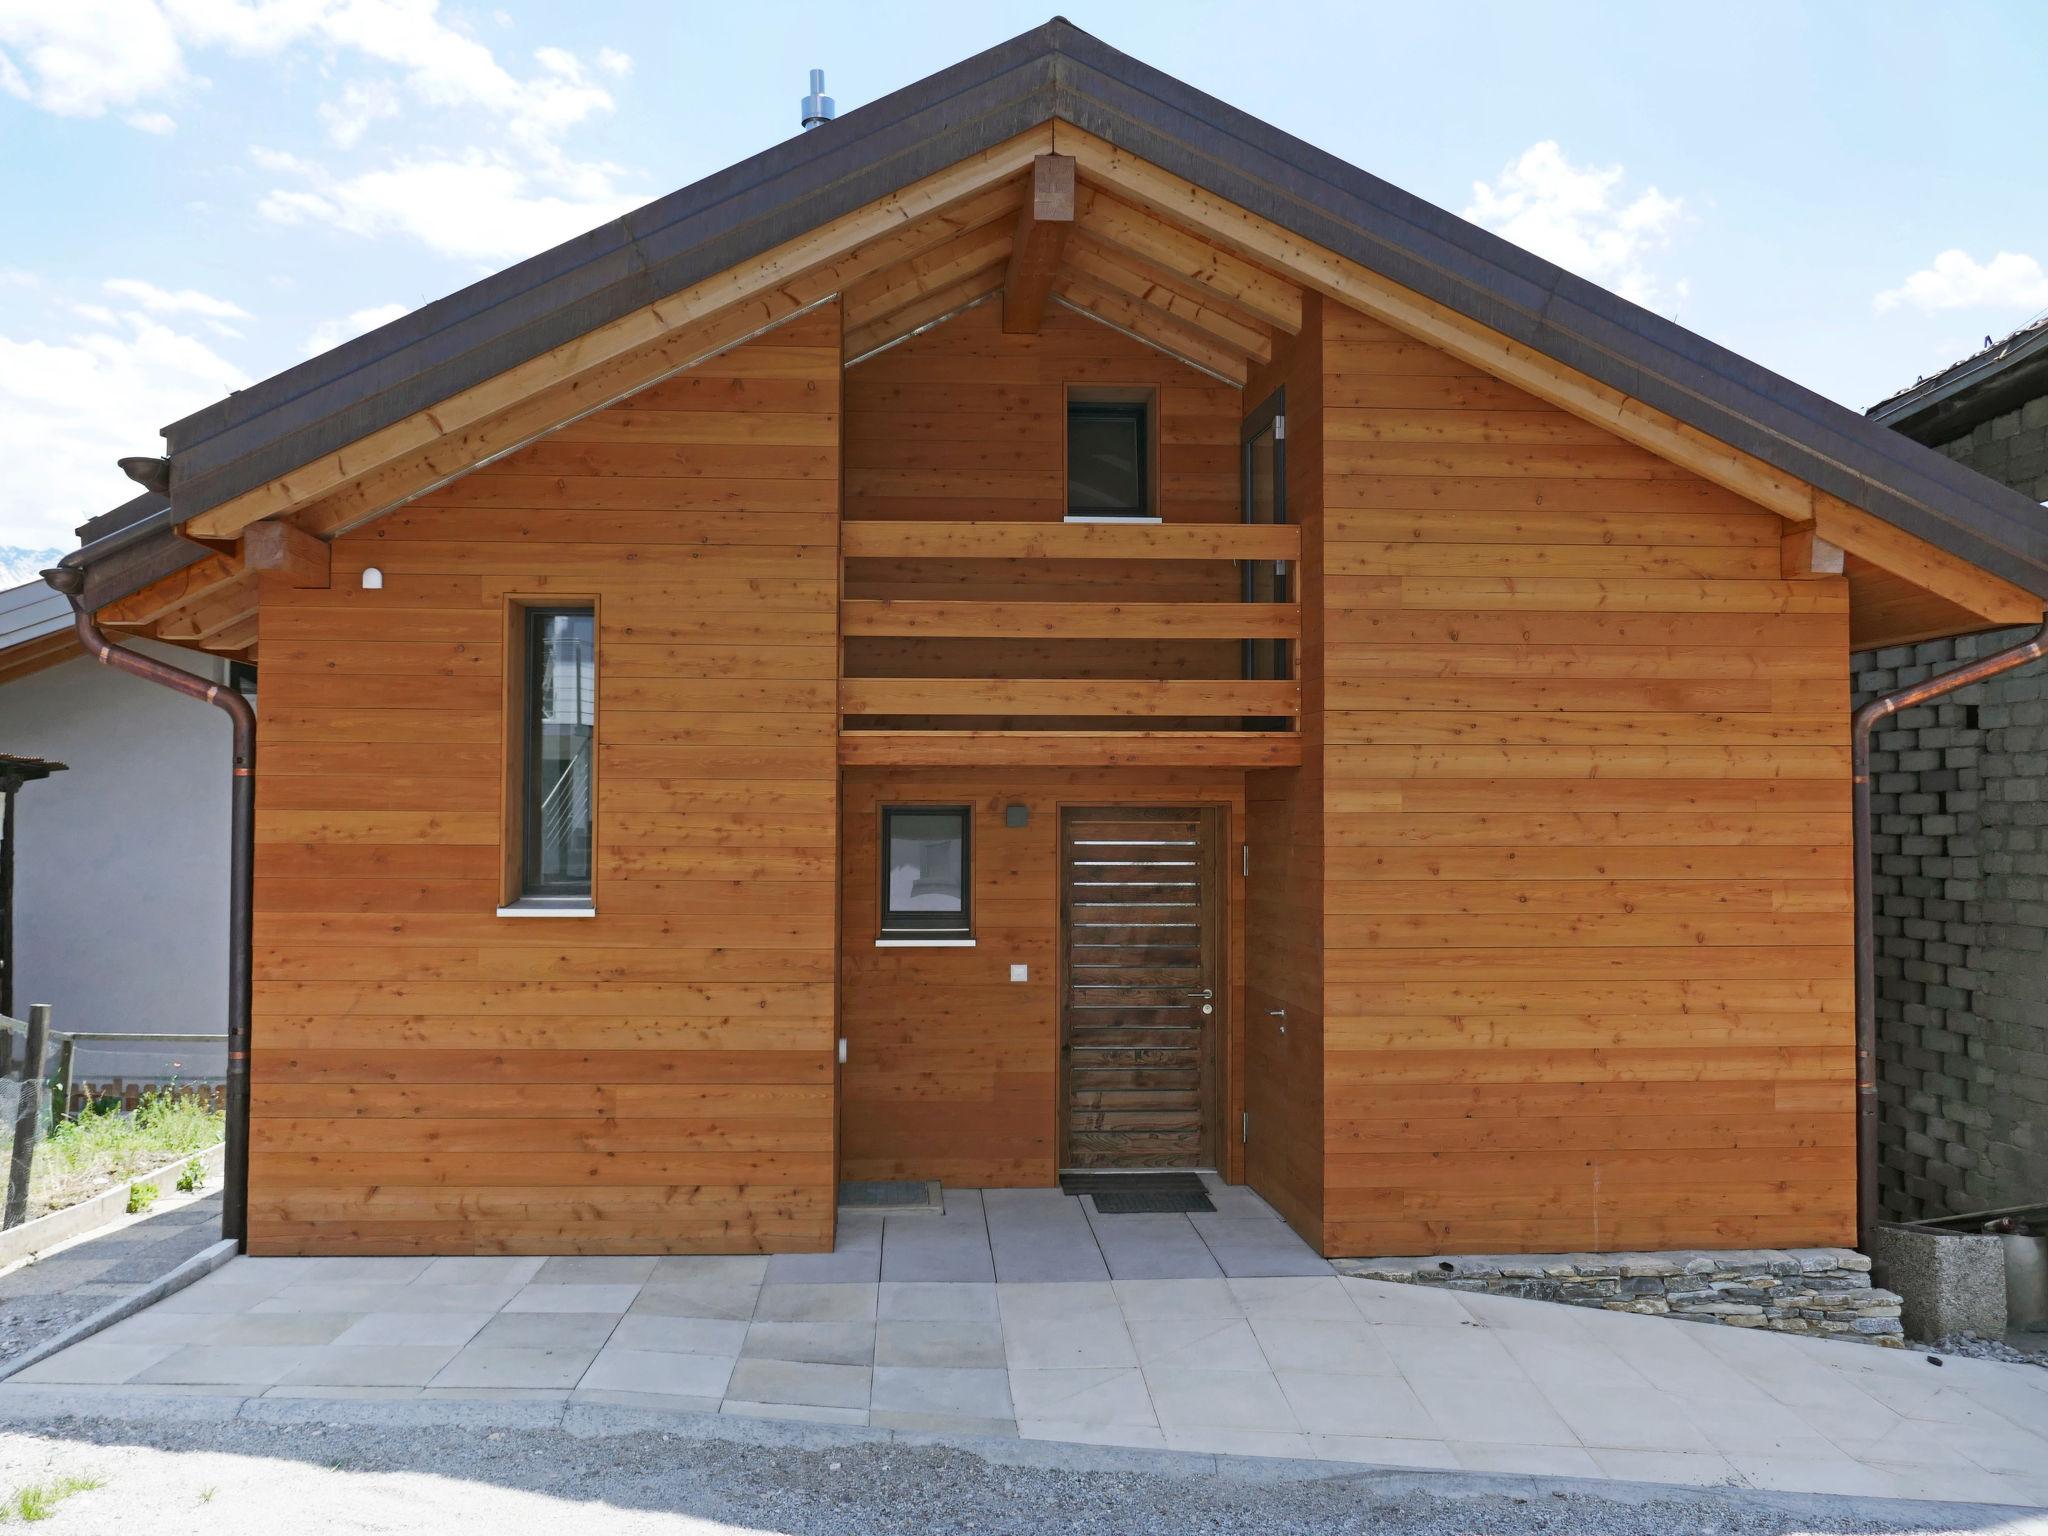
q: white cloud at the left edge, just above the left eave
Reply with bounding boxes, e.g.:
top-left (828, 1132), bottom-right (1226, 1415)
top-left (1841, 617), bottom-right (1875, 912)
top-left (0, 309), bottom-right (248, 549)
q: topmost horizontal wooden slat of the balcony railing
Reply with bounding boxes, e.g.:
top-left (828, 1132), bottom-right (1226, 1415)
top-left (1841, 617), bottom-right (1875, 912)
top-left (840, 520), bottom-right (1300, 559)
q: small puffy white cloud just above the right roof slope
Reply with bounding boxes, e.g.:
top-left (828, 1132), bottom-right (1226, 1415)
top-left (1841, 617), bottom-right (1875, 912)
top-left (1464, 139), bottom-right (1686, 305)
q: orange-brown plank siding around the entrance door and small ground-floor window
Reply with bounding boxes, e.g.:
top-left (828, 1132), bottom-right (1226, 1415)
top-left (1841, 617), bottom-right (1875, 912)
top-left (840, 770), bottom-right (1245, 1188)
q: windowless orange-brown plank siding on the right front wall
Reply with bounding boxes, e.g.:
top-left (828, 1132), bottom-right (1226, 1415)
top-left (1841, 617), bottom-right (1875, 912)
top-left (1302, 303), bottom-right (1855, 1253)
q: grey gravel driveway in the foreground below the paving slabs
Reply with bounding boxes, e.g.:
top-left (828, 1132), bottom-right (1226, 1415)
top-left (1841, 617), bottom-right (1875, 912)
top-left (0, 1403), bottom-right (2023, 1536)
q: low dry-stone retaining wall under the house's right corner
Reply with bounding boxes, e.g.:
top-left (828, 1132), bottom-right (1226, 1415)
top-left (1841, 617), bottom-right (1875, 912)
top-left (1335, 1247), bottom-right (1905, 1348)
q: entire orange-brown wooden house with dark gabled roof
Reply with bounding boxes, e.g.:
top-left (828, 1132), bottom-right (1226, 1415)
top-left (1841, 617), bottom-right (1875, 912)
top-left (44, 20), bottom-right (2048, 1255)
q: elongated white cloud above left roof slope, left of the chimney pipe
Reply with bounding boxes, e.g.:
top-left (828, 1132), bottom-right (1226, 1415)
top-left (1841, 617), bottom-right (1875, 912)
top-left (258, 152), bottom-right (645, 262)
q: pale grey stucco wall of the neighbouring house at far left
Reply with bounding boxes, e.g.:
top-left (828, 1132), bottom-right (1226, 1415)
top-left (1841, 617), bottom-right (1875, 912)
top-left (0, 645), bottom-right (229, 1081)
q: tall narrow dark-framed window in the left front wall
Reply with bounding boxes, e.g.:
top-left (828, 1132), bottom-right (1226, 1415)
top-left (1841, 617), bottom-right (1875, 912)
top-left (520, 608), bottom-right (598, 901)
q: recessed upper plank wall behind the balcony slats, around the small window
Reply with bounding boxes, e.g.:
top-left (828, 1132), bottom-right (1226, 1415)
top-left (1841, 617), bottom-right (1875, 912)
top-left (846, 303), bottom-right (1239, 729)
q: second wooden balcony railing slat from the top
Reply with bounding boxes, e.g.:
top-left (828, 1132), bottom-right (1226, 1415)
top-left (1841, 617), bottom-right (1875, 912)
top-left (840, 598), bottom-right (1300, 639)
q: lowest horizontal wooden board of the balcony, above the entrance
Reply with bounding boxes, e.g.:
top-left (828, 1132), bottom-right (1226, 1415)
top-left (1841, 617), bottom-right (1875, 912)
top-left (840, 731), bottom-right (1300, 768)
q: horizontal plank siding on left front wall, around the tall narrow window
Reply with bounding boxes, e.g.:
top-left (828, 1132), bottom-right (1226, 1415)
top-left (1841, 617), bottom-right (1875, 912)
top-left (250, 303), bottom-right (840, 1253)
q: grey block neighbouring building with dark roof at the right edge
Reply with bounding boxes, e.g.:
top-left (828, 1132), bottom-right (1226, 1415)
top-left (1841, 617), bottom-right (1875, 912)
top-left (1855, 317), bottom-right (2048, 1219)
